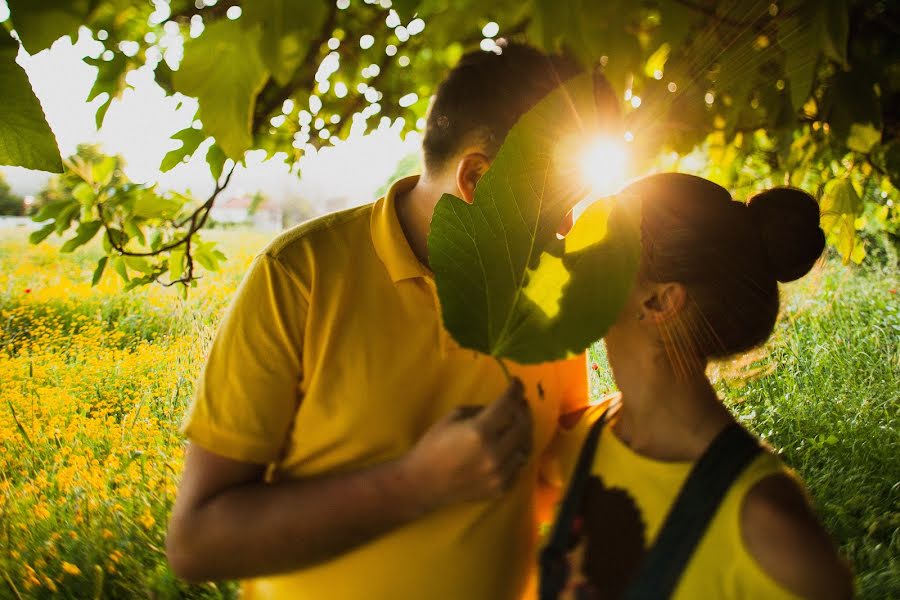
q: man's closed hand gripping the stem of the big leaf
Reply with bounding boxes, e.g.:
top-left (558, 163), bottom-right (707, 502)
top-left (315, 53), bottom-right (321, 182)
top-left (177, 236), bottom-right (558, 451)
top-left (404, 379), bottom-right (532, 512)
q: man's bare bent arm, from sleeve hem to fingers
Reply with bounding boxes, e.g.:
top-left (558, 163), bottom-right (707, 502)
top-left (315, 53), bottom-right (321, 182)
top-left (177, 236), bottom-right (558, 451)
top-left (167, 381), bottom-right (531, 581)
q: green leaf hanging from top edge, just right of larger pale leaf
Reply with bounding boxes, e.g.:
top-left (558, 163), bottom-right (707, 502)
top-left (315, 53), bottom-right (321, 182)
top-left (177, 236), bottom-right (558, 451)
top-left (241, 0), bottom-right (327, 85)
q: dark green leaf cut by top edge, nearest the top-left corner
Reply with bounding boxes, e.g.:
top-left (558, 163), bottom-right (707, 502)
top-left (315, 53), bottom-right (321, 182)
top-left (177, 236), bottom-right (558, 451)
top-left (7, 0), bottom-right (91, 54)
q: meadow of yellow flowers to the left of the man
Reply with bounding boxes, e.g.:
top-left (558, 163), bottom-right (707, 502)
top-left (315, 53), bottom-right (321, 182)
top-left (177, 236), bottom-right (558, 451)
top-left (0, 230), bottom-right (266, 598)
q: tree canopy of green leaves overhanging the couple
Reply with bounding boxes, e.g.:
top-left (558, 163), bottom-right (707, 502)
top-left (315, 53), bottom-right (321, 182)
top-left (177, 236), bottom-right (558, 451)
top-left (0, 0), bottom-right (900, 290)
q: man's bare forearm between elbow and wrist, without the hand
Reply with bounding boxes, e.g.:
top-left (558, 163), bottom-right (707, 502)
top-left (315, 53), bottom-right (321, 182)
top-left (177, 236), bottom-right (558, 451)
top-left (168, 461), bottom-right (423, 581)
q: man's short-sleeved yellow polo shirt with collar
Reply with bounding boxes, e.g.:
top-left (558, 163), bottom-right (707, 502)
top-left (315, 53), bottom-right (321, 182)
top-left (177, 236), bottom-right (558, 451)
top-left (183, 177), bottom-right (587, 600)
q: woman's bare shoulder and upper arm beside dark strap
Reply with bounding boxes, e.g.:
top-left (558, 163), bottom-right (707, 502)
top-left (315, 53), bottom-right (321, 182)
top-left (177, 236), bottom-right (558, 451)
top-left (731, 451), bottom-right (853, 599)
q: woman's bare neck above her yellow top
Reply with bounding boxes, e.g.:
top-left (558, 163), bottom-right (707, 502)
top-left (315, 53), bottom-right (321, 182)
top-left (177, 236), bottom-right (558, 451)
top-left (613, 361), bottom-right (733, 461)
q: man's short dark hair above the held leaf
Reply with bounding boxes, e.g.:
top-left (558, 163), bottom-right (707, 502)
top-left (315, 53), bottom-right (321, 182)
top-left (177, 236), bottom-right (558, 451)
top-left (422, 43), bottom-right (580, 171)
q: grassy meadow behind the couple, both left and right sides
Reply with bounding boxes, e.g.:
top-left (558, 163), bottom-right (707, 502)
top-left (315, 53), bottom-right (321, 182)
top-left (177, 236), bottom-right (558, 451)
top-left (0, 230), bottom-right (900, 599)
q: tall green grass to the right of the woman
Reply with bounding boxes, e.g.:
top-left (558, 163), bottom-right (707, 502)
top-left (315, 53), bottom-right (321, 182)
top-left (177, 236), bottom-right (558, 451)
top-left (722, 266), bottom-right (900, 598)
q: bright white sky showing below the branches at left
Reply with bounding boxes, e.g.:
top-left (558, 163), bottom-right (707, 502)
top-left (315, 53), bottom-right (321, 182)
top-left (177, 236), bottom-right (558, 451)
top-left (0, 13), bottom-right (420, 211)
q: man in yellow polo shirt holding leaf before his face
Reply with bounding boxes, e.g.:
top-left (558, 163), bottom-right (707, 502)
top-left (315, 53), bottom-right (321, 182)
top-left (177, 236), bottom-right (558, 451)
top-left (167, 45), bottom-right (587, 600)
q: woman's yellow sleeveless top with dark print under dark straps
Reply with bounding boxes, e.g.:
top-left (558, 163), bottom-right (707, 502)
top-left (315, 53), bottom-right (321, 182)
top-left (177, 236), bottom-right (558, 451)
top-left (555, 398), bottom-right (799, 600)
